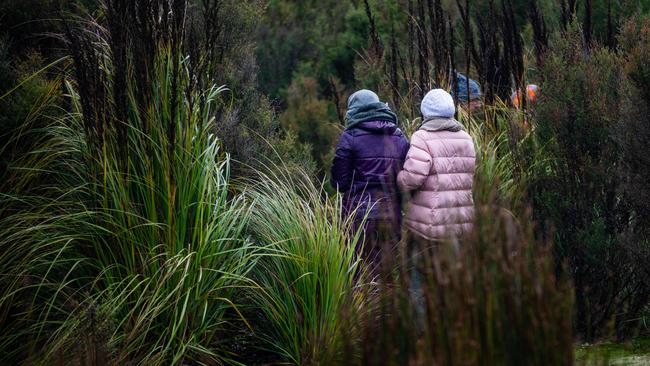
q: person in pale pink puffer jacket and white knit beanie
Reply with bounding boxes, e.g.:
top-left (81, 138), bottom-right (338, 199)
top-left (397, 89), bottom-right (476, 240)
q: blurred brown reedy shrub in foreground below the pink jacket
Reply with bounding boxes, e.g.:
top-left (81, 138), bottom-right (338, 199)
top-left (350, 202), bottom-right (573, 365)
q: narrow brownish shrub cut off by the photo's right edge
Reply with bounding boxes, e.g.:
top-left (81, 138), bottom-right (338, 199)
top-left (613, 19), bottom-right (650, 338)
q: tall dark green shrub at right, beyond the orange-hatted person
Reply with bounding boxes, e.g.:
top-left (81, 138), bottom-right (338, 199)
top-left (530, 20), bottom-right (648, 338)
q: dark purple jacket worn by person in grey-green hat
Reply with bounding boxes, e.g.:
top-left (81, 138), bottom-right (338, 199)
top-left (332, 121), bottom-right (409, 222)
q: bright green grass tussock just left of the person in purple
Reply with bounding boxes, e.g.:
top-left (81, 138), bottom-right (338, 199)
top-left (249, 167), bottom-right (364, 365)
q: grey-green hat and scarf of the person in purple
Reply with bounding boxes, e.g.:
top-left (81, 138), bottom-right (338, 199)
top-left (345, 90), bottom-right (397, 130)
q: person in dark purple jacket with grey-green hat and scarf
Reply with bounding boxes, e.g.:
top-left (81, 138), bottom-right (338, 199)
top-left (332, 90), bottom-right (409, 271)
